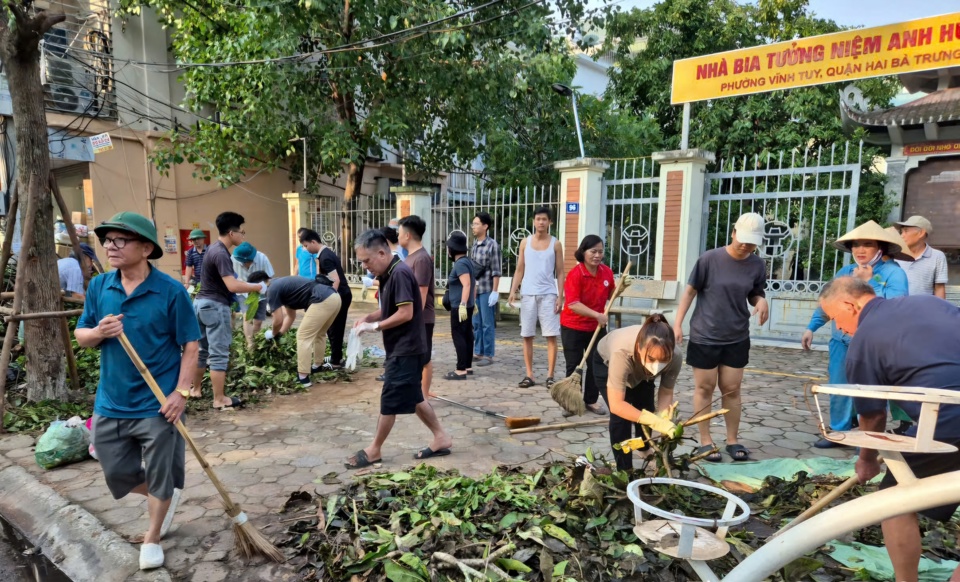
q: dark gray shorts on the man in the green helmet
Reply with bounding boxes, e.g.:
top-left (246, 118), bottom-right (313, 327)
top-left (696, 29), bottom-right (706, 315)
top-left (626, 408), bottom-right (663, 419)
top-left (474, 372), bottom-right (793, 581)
top-left (92, 414), bottom-right (186, 501)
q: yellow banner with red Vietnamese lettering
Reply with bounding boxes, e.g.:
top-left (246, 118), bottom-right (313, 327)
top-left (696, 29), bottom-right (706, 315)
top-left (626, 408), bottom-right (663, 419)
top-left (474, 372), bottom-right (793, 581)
top-left (671, 12), bottom-right (960, 104)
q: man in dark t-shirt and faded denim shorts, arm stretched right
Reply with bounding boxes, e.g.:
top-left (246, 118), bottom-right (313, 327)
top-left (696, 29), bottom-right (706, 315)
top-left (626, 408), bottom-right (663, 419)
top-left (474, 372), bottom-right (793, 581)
top-left (190, 212), bottom-right (267, 409)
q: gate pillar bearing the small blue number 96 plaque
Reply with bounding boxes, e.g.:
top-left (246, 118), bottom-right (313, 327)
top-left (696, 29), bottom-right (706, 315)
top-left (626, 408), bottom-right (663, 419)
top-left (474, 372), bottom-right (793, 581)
top-left (553, 158), bottom-right (610, 273)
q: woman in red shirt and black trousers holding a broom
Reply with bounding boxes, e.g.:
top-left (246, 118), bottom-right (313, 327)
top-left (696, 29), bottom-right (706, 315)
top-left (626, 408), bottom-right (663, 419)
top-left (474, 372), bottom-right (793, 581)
top-left (560, 234), bottom-right (614, 416)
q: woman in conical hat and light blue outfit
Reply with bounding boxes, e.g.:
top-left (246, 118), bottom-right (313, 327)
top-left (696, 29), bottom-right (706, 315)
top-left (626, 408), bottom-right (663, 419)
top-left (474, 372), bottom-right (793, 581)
top-left (800, 220), bottom-right (909, 449)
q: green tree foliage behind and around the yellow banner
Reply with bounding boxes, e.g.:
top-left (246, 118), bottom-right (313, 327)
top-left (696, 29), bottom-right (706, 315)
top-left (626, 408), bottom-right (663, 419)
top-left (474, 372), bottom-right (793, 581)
top-left (607, 0), bottom-right (900, 222)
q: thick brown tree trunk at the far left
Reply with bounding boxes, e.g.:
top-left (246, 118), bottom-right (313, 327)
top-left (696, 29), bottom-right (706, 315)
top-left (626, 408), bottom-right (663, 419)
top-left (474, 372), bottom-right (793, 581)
top-left (0, 9), bottom-right (70, 402)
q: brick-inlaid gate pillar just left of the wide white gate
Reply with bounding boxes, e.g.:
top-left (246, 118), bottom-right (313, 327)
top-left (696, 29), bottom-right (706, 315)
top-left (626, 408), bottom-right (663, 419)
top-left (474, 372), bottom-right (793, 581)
top-left (652, 149), bottom-right (715, 320)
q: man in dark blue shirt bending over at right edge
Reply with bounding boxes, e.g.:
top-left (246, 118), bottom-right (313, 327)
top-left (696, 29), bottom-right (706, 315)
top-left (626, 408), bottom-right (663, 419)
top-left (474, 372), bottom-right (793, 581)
top-left (820, 277), bottom-right (960, 582)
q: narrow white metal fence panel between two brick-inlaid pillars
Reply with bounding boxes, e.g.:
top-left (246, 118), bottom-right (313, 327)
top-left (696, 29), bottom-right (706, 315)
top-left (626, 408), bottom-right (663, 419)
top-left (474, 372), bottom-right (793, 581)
top-left (603, 158), bottom-right (660, 279)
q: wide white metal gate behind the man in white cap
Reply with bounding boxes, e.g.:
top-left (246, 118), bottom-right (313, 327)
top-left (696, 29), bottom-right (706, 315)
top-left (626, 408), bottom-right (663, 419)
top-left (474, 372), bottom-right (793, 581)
top-left (704, 143), bottom-right (863, 338)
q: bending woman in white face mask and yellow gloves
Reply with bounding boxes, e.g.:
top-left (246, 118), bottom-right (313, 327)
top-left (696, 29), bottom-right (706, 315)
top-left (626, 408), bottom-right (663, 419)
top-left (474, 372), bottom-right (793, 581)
top-left (593, 313), bottom-right (683, 471)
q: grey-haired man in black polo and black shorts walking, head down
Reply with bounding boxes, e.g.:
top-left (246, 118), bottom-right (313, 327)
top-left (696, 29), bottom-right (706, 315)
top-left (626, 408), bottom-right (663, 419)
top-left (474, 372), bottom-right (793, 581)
top-left (345, 230), bottom-right (453, 469)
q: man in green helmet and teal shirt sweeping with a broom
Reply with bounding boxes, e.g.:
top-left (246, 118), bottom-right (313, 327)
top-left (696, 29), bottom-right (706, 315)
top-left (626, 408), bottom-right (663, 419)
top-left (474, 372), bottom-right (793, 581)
top-left (75, 212), bottom-right (200, 570)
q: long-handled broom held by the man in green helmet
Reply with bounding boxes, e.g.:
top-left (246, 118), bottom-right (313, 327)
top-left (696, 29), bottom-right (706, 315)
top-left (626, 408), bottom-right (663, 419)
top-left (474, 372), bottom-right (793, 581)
top-left (119, 332), bottom-right (285, 562)
